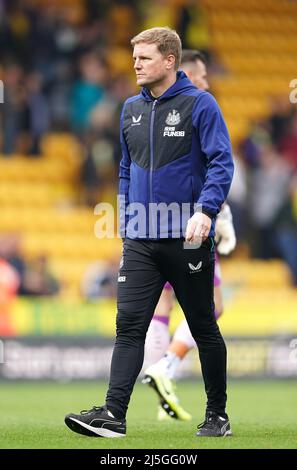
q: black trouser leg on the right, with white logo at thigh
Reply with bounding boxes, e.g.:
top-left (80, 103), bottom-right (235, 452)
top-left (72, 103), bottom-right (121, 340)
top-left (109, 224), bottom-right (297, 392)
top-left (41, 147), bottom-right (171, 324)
top-left (159, 239), bottom-right (227, 414)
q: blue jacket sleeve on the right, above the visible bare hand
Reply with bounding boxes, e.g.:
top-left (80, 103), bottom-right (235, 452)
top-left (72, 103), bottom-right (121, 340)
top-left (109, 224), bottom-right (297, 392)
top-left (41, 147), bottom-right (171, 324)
top-left (193, 92), bottom-right (234, 217)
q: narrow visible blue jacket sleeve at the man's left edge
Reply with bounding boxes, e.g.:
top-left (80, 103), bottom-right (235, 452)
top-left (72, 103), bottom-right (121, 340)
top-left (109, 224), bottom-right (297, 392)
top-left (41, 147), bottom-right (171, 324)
top-left (119, 104), bottom-right (131, 238)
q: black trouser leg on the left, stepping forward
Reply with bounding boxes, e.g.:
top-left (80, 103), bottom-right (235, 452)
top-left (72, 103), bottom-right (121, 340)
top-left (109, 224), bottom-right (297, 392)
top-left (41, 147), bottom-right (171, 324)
top-left (106, 239), bottom-right (165, 416)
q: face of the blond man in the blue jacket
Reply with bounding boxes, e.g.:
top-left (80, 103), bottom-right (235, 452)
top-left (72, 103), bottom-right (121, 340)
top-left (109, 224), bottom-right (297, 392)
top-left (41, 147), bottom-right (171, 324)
top-left (133, 42), bottom-right (173, 88)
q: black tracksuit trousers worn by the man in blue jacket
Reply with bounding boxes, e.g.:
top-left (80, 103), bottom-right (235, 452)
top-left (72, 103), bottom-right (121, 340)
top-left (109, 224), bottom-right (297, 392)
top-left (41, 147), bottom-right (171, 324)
top-left (106, 238), bottom-right (227, 418)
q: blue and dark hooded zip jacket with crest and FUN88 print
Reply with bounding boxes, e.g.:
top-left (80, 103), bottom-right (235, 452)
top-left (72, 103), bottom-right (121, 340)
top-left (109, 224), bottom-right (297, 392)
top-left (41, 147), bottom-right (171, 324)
top-left (119, 71), bottom-right (233, 239)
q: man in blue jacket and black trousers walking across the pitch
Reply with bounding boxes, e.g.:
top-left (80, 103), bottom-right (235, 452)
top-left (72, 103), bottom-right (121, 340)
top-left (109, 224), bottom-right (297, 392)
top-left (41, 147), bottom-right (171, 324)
top-left (66, 28), bottom-right (233, 437)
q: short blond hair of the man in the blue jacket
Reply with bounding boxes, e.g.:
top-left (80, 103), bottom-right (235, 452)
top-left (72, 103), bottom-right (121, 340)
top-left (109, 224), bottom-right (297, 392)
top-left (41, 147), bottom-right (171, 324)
top-left (131, 27), bottom-right (182, 70)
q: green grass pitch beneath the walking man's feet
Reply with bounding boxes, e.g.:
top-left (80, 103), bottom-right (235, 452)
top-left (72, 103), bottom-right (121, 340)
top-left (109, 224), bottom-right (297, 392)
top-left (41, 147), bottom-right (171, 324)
top-left (0, 380), bottom-right (297, 449)
